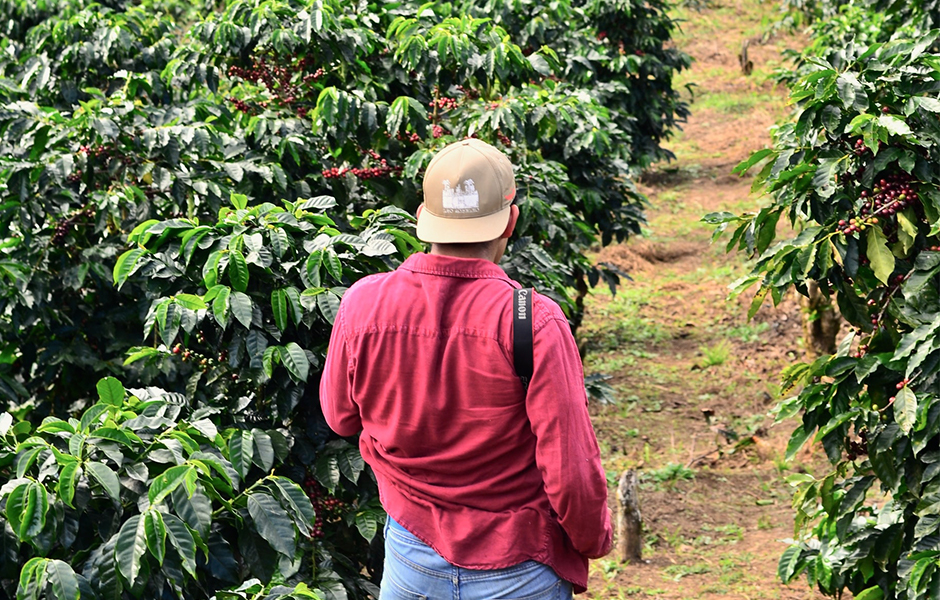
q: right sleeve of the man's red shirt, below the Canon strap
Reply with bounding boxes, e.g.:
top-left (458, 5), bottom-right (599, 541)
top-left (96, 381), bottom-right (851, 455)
top-left (526, 298), bottom-right (613, 558)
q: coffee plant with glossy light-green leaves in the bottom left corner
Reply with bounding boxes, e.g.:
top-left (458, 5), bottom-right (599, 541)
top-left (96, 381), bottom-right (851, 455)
top-left (0, 377), bottom-right (319, 600)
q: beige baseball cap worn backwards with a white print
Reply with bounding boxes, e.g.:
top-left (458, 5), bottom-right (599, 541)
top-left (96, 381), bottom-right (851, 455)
top-left (417, 138), bottom-right (516, 244)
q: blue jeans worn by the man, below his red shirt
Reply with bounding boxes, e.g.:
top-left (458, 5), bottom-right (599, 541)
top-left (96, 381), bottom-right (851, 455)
top-left (379, 517), bottom-right (572, 600)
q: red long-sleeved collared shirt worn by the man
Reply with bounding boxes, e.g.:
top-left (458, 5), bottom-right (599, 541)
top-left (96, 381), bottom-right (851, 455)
top-left (320, 254), bottom-right (612, 592)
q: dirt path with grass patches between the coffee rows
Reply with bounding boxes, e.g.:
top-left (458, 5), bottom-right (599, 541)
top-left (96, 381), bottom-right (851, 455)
top-left (581, 0), bottom-right (822, 600)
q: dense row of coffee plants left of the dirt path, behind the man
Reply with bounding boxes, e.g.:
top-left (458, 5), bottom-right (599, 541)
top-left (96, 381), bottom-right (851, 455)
top-left (0, 0), bottom-right (691, 599)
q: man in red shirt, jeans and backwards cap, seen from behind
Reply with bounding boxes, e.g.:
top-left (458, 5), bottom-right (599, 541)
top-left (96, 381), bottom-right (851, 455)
top-left (320, 139), bottom-right (612, 600)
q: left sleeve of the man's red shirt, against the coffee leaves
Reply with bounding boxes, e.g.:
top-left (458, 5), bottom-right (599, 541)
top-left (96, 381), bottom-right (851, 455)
top-left (320, 304), bottom-right (362, 437)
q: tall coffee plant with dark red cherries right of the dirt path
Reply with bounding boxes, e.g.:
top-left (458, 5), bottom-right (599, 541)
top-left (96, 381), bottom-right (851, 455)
top-left (706, 31), bottom-right (940, 600)
